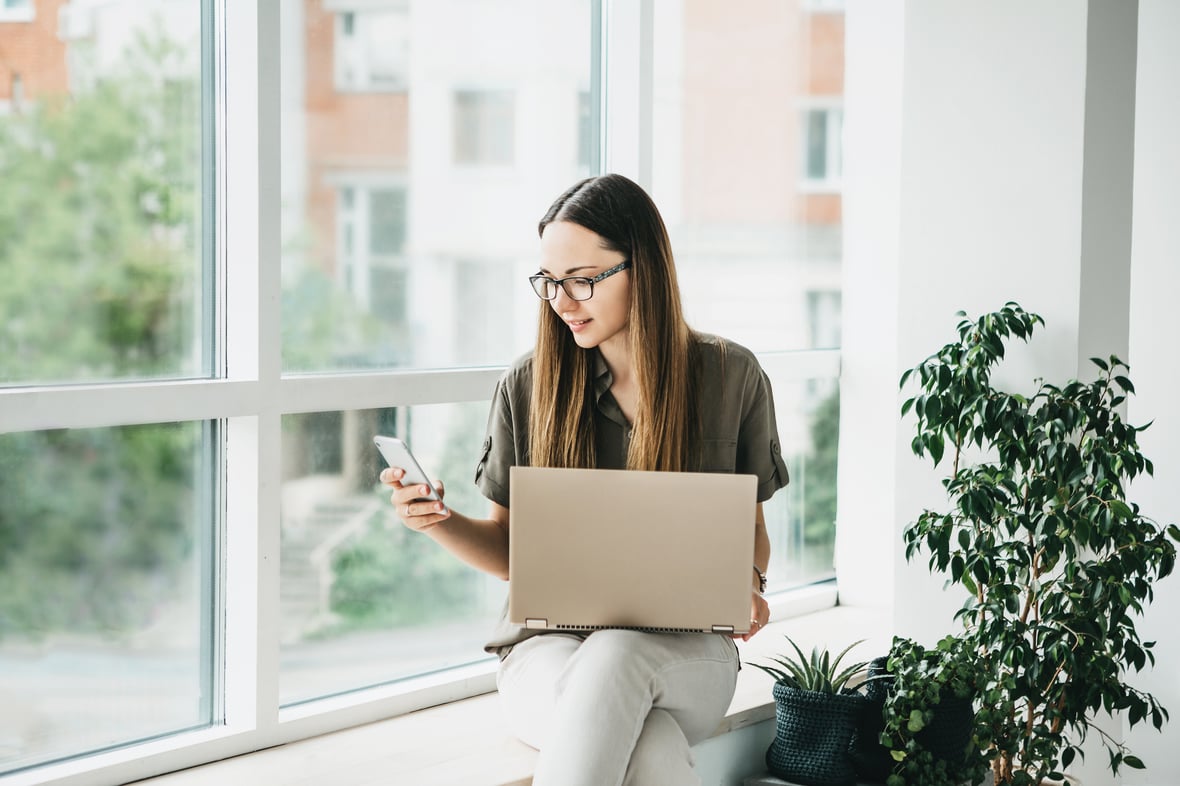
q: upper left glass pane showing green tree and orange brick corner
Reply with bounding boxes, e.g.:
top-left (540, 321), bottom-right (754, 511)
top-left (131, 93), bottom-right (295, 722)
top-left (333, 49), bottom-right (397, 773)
top-left (0, 0), bottom-right (212, 385)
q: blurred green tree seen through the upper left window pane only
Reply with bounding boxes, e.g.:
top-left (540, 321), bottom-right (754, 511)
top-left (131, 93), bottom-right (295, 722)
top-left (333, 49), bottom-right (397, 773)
top-left (0, 33), bottom-right (202, 382)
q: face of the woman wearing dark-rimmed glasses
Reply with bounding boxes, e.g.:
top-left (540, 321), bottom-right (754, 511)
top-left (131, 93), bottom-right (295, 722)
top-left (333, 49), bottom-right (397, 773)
top-left (540, 221), bottom-right (631, 349)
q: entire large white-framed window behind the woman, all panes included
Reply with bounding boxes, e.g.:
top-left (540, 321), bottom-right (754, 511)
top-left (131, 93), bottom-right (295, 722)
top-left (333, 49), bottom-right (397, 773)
top-left (0, 0), bottom-right (840, 782)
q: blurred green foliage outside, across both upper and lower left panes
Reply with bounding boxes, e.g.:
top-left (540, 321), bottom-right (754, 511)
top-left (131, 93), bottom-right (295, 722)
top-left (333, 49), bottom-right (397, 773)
top-left (0, 28), bottom-right (208, 637)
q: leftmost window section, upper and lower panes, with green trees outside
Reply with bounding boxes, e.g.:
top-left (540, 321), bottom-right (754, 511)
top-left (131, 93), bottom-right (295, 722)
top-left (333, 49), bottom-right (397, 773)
top-left (0, 1), bottom-right (212, 774)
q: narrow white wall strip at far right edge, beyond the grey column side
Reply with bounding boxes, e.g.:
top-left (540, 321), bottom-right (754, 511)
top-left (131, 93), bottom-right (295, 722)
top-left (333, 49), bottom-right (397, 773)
top-left (1125, 0), bottom-right (1180, 786)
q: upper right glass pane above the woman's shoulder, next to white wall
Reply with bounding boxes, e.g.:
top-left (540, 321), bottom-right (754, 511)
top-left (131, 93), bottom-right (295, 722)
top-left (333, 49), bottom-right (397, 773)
top-left (653, 0), bottom-right (844, 352)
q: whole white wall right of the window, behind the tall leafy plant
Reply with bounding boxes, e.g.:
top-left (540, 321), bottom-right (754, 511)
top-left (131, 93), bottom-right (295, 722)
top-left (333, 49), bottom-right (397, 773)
top-left (837, 0), bottom-right (1180, 786)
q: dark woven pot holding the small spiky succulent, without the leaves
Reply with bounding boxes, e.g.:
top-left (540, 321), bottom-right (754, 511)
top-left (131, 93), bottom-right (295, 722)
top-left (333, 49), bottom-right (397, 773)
top-left (766, 682), bottom-right (865, 786)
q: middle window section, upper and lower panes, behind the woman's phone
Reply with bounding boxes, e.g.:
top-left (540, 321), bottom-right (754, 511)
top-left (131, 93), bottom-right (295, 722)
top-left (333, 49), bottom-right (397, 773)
top-left (280, 0), bottom-right (591, 706)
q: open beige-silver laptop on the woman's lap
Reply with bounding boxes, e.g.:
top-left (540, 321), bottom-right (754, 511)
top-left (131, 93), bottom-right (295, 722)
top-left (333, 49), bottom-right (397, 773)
top-left (509, 466), bottom-right (758, 634)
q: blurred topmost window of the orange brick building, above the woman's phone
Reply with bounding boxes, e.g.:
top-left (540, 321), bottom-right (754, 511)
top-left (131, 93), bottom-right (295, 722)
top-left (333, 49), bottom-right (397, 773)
top-left (334, 7), bottom-right (409, 93)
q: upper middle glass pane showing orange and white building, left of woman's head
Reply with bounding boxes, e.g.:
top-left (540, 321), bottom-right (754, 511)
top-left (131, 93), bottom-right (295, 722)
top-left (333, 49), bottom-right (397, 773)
top-left (282, 0), bottom-right (597, 372)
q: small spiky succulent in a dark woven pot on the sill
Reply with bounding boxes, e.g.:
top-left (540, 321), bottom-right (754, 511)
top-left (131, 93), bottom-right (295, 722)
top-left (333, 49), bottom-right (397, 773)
top-left (750, 637), bottom-right (866, 786)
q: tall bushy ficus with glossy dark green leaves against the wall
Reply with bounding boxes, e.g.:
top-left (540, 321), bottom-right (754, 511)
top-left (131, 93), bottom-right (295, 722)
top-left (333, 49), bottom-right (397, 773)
top-left (902, 303), bottom-right (1180, 785)
